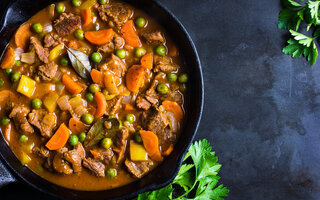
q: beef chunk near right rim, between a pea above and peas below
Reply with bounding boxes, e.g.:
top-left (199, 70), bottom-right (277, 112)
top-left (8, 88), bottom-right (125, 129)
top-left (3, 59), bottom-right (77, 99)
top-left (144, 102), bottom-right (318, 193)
top-left (153, 55), bottom-right (178, 73)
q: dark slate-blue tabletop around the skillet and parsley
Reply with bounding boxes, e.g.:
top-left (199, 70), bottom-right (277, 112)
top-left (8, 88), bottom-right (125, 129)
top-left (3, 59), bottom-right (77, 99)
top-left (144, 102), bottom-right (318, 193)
top-left (0, 0), bottom-right (320, 200)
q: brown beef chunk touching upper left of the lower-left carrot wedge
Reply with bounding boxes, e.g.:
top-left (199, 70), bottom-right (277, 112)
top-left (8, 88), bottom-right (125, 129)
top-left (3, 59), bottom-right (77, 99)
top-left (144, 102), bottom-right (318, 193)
top-left (29, 109), bottom-right (57, 138)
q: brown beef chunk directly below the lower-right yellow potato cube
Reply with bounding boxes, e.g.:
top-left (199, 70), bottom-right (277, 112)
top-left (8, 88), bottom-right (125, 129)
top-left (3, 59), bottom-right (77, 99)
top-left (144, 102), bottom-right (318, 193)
top-left (124, 159), bottom-right (153, 178)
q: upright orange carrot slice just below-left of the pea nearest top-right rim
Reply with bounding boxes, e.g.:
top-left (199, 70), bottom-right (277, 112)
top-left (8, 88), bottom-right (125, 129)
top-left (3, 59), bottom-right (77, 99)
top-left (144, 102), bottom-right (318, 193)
top-left (120, 20), bottom-right (141, 47)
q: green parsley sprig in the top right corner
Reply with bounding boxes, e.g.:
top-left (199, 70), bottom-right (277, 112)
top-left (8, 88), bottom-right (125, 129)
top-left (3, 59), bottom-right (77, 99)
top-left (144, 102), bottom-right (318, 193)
top-left (278, 0), bottom-right (320, 65)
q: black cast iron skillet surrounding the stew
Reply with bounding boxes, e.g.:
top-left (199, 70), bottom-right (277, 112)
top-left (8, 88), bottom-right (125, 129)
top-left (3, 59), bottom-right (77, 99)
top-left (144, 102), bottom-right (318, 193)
top-left (0, 0), bottom-right (203, 200)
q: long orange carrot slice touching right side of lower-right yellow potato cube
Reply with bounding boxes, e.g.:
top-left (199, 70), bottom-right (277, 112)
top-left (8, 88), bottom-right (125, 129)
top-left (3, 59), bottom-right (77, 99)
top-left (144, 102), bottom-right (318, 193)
top-left (140, 130), bottom-right (162, 161)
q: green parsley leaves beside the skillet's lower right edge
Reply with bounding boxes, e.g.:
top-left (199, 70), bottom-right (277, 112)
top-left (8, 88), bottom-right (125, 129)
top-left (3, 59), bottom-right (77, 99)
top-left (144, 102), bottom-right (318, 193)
top-left (137, 139), bottom-right (229, 200)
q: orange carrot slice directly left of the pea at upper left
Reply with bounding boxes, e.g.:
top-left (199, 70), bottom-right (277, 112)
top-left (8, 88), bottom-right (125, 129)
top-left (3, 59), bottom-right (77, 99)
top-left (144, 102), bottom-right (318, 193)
top-left (14, 24), bottom-right (32, 51)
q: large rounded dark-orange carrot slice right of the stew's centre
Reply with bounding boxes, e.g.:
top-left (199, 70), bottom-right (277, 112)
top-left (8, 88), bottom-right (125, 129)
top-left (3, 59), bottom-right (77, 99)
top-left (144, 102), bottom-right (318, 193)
top-left (126, 65), bottom-right (146, 93)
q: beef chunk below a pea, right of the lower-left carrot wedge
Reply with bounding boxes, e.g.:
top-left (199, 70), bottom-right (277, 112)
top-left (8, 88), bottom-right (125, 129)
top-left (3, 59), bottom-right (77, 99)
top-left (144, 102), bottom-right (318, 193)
top-left (63, 142), bottom-right (85, 173)
